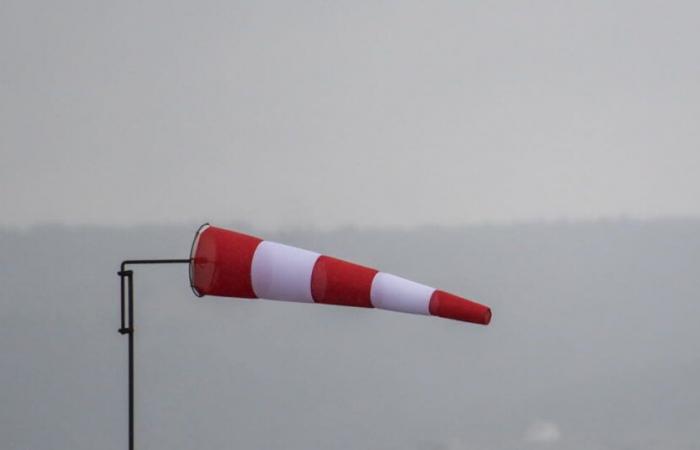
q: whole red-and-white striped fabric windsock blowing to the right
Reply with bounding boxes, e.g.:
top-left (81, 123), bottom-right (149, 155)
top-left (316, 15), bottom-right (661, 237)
top-left (190, 224), bottom-right (491, 325)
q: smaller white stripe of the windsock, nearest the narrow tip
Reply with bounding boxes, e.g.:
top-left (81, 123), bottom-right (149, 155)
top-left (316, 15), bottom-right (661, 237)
top-left (370, 272), bottom-right (435, 315)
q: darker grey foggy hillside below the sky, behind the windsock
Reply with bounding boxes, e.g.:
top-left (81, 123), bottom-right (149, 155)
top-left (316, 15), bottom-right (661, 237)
top-left (0, 220), bottom-right (700, 450)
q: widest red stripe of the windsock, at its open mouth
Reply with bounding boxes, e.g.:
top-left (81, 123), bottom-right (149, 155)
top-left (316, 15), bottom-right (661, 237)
top-left (192, 227), bottom-right (262, 298)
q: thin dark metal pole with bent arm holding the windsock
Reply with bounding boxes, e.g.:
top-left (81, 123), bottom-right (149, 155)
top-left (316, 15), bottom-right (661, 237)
top-left (117, 259), bottom-right (190, 450)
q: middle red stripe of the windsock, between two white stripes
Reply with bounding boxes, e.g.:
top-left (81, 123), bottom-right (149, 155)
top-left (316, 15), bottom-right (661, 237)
top-left (311, 255), bottom-right (377, 308)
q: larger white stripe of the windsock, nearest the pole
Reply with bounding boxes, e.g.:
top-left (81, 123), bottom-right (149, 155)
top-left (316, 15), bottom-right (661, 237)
top-left (250, 241), bottom-right (321, 303)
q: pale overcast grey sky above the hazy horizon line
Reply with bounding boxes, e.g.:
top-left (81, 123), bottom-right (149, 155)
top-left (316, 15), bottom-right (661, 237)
top-left (0, 0), bottom-right (700, 228)
